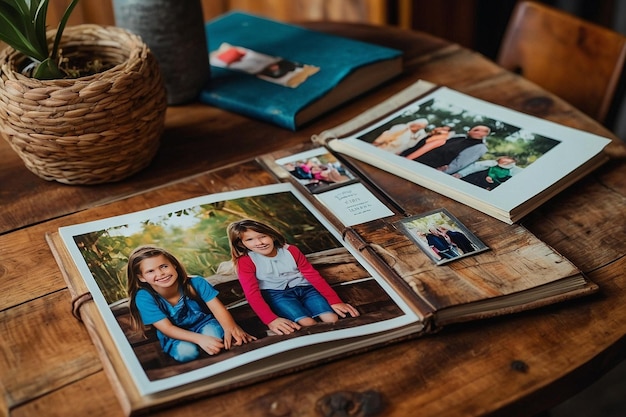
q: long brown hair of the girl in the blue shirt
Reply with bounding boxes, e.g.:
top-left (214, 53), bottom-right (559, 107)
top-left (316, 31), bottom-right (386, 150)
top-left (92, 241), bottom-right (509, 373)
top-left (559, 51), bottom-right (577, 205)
top-left (126, 246), bottom-right (208, 336)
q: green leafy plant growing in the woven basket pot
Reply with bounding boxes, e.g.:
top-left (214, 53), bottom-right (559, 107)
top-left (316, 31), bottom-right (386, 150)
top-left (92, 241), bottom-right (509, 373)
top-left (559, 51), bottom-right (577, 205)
top-left (0, 0), bottom-right (78, 80)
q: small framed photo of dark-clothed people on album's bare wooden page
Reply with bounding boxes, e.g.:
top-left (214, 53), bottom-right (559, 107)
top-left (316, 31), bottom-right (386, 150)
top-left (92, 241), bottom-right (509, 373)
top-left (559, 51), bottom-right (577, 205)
top-left (398, 209), bottom-right (489, 265)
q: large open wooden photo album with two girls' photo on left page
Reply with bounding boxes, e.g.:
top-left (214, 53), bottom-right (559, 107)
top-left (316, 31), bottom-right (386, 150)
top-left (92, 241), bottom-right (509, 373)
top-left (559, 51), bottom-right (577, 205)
top-left (46, 147), bottom-right (598, 415)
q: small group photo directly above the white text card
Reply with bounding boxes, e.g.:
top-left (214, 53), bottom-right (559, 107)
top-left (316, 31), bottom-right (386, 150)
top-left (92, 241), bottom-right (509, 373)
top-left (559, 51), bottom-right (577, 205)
top-left (276, 149), bottom-right (358, 194)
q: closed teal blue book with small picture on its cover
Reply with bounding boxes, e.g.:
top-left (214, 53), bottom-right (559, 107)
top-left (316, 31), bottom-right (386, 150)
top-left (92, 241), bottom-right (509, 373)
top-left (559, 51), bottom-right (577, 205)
top-left (200, 12), bottom-right (402, 130)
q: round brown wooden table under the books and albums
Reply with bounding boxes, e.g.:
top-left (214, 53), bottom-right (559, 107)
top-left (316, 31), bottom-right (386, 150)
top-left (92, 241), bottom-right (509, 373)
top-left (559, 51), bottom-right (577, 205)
top-left (0, 23), bottom-right (626, 417)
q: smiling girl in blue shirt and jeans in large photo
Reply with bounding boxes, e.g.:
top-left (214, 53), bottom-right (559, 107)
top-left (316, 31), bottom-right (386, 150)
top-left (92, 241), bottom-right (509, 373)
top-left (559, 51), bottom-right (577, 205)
top-left (127, 246), bottom-right (256, 362)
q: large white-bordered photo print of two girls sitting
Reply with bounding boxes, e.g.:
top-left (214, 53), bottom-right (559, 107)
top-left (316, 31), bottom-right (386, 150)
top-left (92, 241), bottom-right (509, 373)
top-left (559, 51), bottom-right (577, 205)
top-left (60, 184), bottom-right (418, 394)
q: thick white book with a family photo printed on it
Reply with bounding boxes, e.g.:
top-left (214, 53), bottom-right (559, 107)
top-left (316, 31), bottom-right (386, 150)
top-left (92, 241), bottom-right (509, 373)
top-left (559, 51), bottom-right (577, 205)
top-left (312, 80), bottom-right (610, 223)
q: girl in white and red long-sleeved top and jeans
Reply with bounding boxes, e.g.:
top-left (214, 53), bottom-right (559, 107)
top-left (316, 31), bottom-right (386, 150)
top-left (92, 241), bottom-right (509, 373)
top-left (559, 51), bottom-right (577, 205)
top-left (228, 219), bottom-right (359, 334)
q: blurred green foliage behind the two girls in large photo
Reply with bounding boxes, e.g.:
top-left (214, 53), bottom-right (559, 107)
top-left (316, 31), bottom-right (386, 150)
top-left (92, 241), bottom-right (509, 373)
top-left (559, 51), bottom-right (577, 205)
top-left (74, 192), bottom-right (341, 304)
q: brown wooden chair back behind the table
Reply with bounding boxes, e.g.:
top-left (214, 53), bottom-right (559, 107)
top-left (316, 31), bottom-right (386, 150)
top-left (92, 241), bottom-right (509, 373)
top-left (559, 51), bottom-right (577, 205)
top-left (497, 1), bottom-right (626, 124)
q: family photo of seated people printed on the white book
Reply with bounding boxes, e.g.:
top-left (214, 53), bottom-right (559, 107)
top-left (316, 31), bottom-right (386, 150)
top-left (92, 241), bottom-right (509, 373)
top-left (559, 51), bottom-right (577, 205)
top-left (358, 92), bottom-right (559, 191)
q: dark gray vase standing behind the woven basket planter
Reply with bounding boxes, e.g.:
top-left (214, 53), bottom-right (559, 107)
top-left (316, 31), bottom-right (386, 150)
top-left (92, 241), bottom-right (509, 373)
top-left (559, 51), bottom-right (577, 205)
top-left (113, 0), bottom-right (210, 105)
